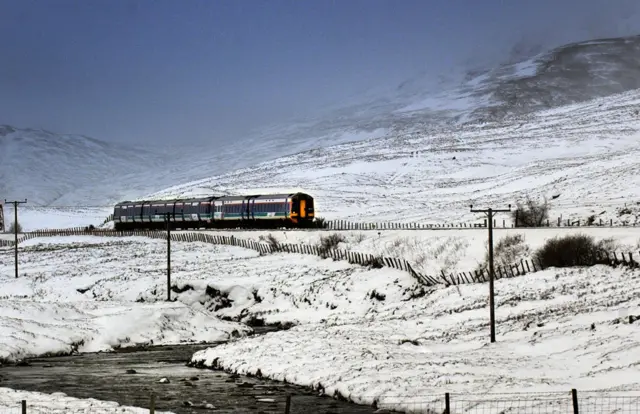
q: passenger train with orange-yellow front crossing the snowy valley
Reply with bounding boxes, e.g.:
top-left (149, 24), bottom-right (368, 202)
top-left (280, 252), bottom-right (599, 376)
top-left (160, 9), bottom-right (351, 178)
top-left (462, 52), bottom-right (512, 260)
top-left (113, 192), bottom-right (315, 230)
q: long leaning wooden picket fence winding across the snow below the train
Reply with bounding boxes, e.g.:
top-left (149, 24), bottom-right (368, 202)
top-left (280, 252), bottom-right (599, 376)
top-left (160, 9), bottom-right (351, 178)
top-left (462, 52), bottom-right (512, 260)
top-left (5, 227), bottom-right (640, 286)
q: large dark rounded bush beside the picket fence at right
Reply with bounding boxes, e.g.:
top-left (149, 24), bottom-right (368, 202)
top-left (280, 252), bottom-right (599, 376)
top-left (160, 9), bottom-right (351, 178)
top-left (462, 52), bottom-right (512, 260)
top-left (534, 234), bottom-right (614, 268)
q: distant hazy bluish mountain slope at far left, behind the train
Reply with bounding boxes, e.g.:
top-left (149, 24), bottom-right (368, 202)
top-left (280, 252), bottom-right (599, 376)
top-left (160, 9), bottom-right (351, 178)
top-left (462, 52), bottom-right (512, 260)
top-left (0, 125), bottom-right (168, 205)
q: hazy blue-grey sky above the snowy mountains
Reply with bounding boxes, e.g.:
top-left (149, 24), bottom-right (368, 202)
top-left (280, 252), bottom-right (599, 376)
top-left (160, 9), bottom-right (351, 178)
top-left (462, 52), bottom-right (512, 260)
top-left (0, 0), bottom-right (640, 145)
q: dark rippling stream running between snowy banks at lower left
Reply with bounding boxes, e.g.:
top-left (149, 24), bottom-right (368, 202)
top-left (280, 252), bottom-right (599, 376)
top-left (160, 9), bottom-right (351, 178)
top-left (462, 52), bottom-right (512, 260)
top-left (0, 345), bottom-right (381, 414)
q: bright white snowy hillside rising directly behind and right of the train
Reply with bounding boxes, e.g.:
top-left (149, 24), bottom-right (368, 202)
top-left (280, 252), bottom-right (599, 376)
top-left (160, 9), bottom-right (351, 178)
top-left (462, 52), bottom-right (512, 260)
top-left (149, 85), bottom-right (640, 224)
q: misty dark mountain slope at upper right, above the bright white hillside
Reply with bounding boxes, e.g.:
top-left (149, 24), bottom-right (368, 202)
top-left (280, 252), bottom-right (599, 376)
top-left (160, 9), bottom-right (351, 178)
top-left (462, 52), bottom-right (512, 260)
top-left (258, 36), bottom-right (640, 145)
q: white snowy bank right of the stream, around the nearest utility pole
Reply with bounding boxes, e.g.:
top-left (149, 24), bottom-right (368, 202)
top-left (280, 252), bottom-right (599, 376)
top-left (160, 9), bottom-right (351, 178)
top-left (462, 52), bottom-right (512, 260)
top-left (192, 266), bottom-right (640, 408)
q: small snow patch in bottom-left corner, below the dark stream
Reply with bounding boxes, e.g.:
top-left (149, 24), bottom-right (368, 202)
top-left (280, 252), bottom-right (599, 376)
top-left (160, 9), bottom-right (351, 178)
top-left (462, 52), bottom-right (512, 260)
top-left (0, 388), bottom-right (169, 414)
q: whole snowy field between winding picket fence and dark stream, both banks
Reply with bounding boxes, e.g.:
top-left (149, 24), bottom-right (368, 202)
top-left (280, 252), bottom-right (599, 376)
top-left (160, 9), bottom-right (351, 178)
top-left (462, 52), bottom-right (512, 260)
top-left (0, 232), bottom-right (640, 412)
